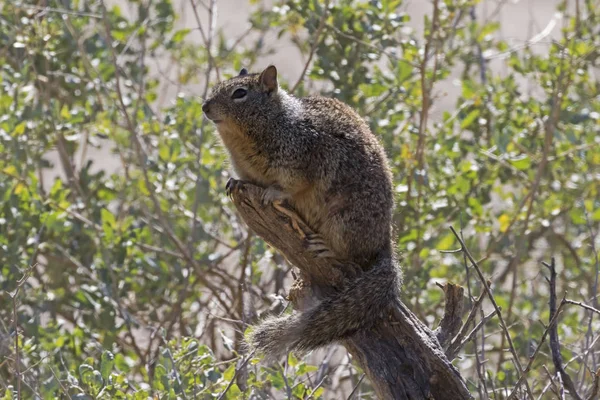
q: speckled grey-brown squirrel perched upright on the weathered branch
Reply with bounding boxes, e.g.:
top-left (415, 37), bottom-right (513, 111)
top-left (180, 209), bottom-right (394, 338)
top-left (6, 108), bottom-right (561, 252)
top-left (202, 65), bottom-right (401, 360)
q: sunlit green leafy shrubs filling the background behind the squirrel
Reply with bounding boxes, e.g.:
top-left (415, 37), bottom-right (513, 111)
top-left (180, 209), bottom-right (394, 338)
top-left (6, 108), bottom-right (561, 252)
top-left (0, 0), bottom-right (600, 399)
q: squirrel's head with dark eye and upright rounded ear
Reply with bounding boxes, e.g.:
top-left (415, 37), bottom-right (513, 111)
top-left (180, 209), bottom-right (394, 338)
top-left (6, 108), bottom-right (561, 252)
top-left (202, 65), bottom-right (281, 131)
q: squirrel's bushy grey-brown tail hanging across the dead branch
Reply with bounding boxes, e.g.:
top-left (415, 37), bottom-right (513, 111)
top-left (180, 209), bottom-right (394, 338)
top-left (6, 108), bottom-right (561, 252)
top-left (249, 252), bottom-right (401, 361)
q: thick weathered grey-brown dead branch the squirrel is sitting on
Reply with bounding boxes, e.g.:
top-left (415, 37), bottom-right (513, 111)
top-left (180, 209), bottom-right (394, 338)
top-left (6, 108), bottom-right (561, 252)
top-left (227, 179), bottom-right (472, 400)
